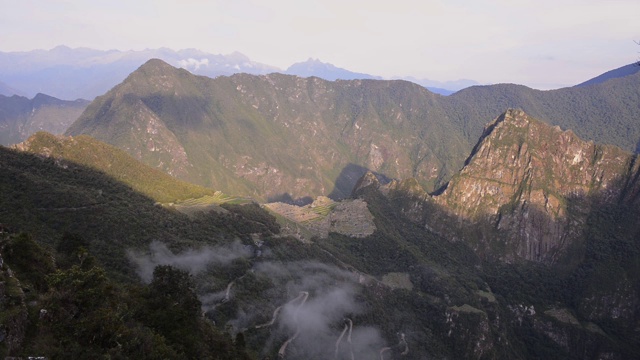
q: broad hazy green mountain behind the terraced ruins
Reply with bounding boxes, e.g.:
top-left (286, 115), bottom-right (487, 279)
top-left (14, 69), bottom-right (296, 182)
top-left (67, 60), bottom-right (467, 200)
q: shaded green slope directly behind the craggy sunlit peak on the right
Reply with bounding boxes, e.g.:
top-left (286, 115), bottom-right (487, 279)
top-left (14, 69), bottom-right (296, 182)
top-left (448, 72), bottom-right (640, 151)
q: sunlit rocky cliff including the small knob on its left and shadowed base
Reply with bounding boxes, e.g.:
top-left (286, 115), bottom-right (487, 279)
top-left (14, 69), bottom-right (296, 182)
top-left (363, 110), bottom-right (640, 263)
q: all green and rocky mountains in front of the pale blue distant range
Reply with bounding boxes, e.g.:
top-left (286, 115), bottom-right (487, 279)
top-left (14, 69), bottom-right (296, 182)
top-left (0, 49), bottom-right (640, 360)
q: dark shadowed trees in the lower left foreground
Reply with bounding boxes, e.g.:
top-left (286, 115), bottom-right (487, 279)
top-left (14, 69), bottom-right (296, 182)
top-left (0, 233), bottom-right (249, 359)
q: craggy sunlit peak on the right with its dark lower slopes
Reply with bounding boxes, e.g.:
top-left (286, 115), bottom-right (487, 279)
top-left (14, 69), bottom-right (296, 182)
top-left (354, 110), bottom-right (640, 358)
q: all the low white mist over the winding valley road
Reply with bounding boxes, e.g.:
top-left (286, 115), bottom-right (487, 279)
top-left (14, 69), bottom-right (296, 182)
top-left (128, 242), bottom-right (387, 359)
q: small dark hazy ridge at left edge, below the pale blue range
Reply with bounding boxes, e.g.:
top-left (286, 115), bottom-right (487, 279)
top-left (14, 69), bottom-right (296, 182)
top-left (0, 94), bottom-right (89, 145)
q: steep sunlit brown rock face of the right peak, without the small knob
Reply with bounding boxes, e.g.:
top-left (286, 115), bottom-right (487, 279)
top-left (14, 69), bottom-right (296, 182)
top-left (433, 110), bottom-right (637, 262)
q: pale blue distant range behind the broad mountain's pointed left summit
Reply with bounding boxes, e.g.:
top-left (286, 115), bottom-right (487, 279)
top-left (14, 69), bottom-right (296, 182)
top-left (0, 46), bottom-right (278, 100)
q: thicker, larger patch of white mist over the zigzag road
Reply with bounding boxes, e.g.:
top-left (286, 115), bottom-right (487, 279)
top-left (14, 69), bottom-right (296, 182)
top-left (240, 262), bottom-right (387, 359)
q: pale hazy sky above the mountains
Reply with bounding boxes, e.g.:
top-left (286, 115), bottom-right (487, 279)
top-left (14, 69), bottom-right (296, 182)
top-left (0, 0), bottom-right (640, 88)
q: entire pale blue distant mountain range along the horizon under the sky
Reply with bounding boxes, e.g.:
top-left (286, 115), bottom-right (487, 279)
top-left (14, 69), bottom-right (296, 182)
top-left (0, 46), bottom-right (477, 100)
